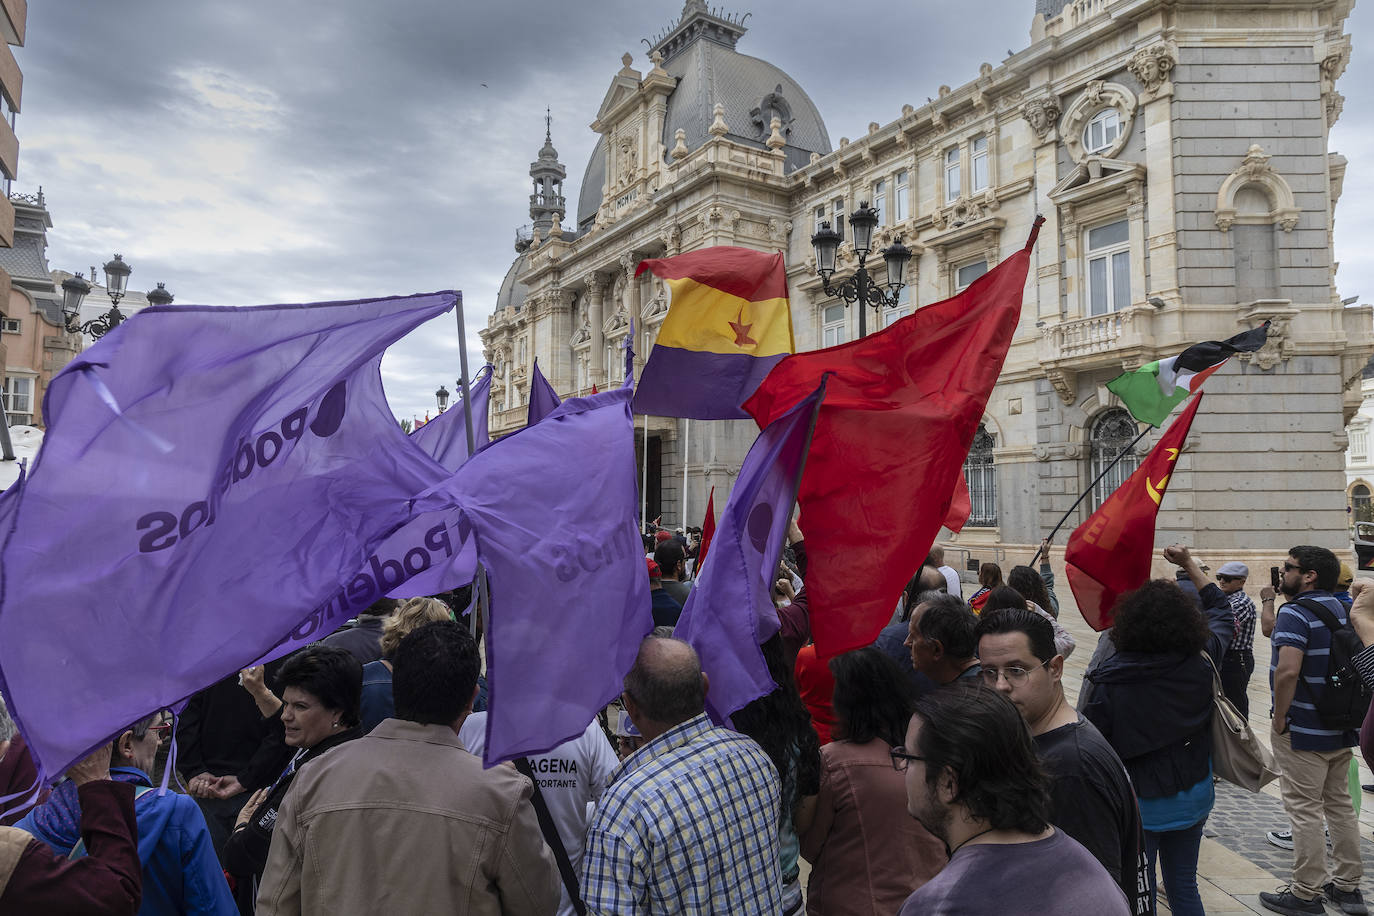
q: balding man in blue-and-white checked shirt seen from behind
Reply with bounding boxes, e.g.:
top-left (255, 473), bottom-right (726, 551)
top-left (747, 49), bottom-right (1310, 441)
top-left (583, 636), bottom-right (782, 916)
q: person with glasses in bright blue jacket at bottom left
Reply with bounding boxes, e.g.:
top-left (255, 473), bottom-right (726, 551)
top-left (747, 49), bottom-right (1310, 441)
top-left (16, 713), bottom-right (239, 916)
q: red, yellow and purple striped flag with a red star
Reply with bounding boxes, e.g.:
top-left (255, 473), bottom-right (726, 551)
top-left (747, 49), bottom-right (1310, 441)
top-left (633, 246), bottom-right (797, 420)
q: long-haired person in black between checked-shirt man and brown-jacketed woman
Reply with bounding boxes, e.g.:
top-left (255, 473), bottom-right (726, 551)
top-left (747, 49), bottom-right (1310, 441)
top-left (730, 633), bottom-right (820, 916)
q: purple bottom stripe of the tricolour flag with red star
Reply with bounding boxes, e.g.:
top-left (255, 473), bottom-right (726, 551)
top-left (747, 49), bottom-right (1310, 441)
top-left (635, 343), bottom-right (787, 420)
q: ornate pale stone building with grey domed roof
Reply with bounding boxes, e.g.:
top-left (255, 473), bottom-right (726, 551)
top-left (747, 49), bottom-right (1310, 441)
top-left (482, 0), bottom-right (1374, 574)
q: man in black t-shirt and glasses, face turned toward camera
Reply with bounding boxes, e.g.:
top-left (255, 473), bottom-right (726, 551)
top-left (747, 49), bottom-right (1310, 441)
top-left (977, 610), bottom-right (1151, 915)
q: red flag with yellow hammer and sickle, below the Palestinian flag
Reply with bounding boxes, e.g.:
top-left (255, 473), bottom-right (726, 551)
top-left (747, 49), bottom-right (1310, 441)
top-left (1063, 393), bottom-right (1202, 630)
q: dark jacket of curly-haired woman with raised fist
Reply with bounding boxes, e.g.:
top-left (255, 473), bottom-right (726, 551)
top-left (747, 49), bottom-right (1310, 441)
top-left (1083, 582), bottom-right (1235, 798)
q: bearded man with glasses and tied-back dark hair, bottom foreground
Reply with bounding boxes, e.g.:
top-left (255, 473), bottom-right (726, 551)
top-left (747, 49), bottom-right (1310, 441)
top-left (892, 683), bottom-right (1131, 916)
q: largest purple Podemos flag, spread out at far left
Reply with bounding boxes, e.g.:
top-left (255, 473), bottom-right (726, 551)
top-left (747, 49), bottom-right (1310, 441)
top-left (0, 293), bottom-right (458, 777)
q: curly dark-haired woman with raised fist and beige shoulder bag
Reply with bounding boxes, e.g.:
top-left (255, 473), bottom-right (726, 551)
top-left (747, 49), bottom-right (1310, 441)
top-left (1083, 545), bottom-right (1235, 916)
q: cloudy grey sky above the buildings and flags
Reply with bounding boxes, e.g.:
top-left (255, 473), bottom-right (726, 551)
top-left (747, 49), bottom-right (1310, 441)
top-left (15, 0), bottom-right (1374, 416)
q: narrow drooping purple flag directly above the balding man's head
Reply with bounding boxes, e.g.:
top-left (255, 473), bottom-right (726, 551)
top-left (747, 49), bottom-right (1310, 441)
top-left (673, 382), bottom-right (826, 721)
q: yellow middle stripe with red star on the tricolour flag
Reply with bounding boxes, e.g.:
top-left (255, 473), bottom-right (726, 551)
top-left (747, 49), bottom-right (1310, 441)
top-left (657, 277), bottom-right (796, 356)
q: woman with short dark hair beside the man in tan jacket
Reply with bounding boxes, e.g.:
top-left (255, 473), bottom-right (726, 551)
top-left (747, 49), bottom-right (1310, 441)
top-left (223, 645), bottom-right (363, 901)
